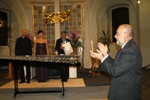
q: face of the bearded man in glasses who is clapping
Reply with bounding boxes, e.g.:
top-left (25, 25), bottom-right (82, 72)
top-left (115, 26), bottom-right (126, 46)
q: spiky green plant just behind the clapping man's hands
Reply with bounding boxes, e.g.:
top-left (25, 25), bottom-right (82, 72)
top-left (98, 30), bottom-right (112, 52)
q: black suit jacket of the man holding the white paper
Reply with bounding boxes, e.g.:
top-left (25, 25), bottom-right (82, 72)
top-left (55, 38), bottom-right (70, 54)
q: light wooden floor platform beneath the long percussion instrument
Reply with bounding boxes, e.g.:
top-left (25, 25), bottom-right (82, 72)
top-left (0, 78), bottom-right (85, 88)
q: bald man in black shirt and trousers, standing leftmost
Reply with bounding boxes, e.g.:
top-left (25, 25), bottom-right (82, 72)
top-left (15, 29), bottom-right (32, 83)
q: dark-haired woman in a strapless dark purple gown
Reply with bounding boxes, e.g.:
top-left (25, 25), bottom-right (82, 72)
top-left (33, 30), bottom-right (49, 82)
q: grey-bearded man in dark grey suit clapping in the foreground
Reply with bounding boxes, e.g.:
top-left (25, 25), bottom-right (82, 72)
top-left (90, 24), bottom-right (142, 100)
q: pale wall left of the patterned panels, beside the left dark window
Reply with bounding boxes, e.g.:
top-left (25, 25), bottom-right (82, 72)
top-left (0, 0), bottom-right (31, 55)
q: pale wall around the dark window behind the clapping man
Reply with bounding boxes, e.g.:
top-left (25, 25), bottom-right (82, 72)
top-left (85, 0), bottom-right (150, 68)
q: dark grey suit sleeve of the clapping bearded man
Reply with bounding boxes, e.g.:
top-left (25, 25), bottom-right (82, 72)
top-left (101, 48), bottom-right (138, 77)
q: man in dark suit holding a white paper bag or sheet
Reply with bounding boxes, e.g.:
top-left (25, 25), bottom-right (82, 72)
top-left (55, 31), bottom-right (71, 82)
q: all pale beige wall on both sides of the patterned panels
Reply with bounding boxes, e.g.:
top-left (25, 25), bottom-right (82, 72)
top-left (0, 0), bottom-right (150, 68)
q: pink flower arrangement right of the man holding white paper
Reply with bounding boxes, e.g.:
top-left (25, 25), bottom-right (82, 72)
top-left (70, 32), bottom-right (82, 48)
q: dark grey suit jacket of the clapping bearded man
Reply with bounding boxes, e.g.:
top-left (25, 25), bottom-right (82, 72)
top-left (101, 40), bottom-right (142, 100)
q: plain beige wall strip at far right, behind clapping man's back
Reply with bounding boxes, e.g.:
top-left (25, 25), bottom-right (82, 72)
top-left (139, 0), bottom-right (150, 66)
